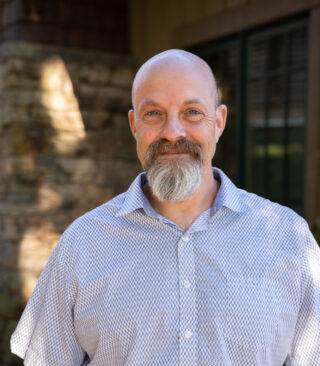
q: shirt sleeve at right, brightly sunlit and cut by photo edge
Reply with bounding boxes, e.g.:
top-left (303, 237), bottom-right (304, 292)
top-left (286, 225), bottom-right (320, 366)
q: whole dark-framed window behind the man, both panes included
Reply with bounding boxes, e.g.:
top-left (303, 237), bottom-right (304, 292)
top-left (191, 19), bottom-right (308, 214)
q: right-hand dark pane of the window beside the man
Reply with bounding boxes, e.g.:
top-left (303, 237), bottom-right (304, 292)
top-left (248, 22), bottom-right (307, 213)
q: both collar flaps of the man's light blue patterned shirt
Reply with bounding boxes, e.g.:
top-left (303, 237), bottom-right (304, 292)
top-left (116, 168), bottom-right (248, 216)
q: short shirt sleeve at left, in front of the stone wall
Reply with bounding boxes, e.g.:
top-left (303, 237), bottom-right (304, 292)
top-left (11, 236), bottom-right (85, 366)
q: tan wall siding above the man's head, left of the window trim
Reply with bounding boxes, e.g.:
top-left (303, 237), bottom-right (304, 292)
top-left (130, 0), bottom-right (252, 62)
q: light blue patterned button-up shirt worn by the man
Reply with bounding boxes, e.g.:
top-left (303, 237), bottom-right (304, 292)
top-left (11, 169), bottom-right (320, 366)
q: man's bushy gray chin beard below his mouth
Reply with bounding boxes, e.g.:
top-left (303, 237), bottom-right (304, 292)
top-left (147, 157), bottom-right (202, 203)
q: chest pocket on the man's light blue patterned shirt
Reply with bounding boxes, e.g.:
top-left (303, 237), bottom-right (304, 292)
top-left (225, 277), bottom-right (281, 348)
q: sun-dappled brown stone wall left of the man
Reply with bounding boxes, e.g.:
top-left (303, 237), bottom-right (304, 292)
top-left (0, 43), bottom-right (139, 365)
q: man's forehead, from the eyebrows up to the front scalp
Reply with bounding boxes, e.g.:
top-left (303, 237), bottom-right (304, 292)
top-left (133, 62), bottom-right (214, 107)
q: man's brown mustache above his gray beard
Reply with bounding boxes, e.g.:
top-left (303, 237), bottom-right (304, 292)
top-left (145, 138), bottom-right (202, 169)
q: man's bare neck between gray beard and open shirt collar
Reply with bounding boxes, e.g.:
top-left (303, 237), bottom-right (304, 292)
top-left (143, 166), bottom-right (219, 231)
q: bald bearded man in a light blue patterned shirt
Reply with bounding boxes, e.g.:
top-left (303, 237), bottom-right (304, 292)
top-left (11, 50), bottom-right (320, 366)
